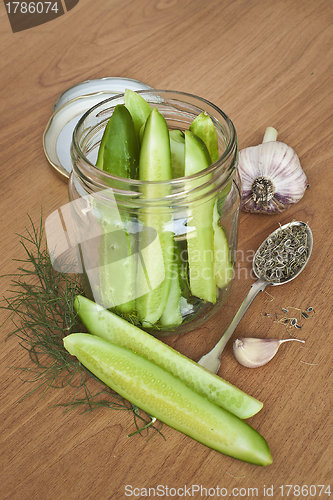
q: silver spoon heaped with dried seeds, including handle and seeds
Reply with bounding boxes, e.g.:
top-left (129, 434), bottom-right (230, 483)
top-left (198, 221), bottom-right (313, 373)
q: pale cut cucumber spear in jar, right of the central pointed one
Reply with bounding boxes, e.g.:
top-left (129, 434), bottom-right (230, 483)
top-left (185, 130), bottom-right (216, 304)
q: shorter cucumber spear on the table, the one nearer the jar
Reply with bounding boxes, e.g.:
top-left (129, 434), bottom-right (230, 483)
top-left (74, 295), bottom-right (263, 419)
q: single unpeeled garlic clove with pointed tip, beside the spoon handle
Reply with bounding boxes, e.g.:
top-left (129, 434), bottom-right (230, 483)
top-left (233, 337), bottom-right (304, 368)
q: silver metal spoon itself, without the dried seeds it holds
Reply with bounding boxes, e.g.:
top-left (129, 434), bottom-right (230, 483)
top-left (198, 221), bottom-right (313, 373)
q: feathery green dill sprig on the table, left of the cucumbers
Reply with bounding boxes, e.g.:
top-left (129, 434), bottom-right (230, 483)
top-left (0, 214), bottom-right (160, 435)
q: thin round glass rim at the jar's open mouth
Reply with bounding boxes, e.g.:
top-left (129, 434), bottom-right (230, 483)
top-left (71, 89), bottom-right (237, 192)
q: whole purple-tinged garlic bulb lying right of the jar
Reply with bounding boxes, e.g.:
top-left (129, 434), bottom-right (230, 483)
top-left (239, 127), bottom-right (308, 214)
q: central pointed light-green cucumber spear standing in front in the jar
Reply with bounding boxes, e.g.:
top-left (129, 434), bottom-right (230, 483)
top-left (136, 108), bottom-right (173, 328)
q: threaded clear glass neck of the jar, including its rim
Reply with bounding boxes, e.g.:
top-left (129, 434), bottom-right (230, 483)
top-left (71, 90), bottom-right (238, 206)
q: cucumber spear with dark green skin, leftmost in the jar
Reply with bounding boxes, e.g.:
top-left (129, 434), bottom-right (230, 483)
top-left (94, 104), bottom-right (139, 313)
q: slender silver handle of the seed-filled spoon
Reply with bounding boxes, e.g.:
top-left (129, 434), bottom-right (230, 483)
top-left (198, 279), bottom-right (269, 373)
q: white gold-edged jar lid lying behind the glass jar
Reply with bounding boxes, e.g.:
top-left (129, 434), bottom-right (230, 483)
top-left (43, 77), bottom-right (152, 182)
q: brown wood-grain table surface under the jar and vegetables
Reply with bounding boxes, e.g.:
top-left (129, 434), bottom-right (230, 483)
top-left (0, 0), bottom-right (333, 500)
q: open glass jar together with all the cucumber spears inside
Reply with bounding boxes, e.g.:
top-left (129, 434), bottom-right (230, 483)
top-left (69, 90), bottom-right (240, 336)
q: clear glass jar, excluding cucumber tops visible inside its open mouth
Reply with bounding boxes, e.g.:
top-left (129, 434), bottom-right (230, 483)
top-left (69, 90), bottom-right (241, 337)
